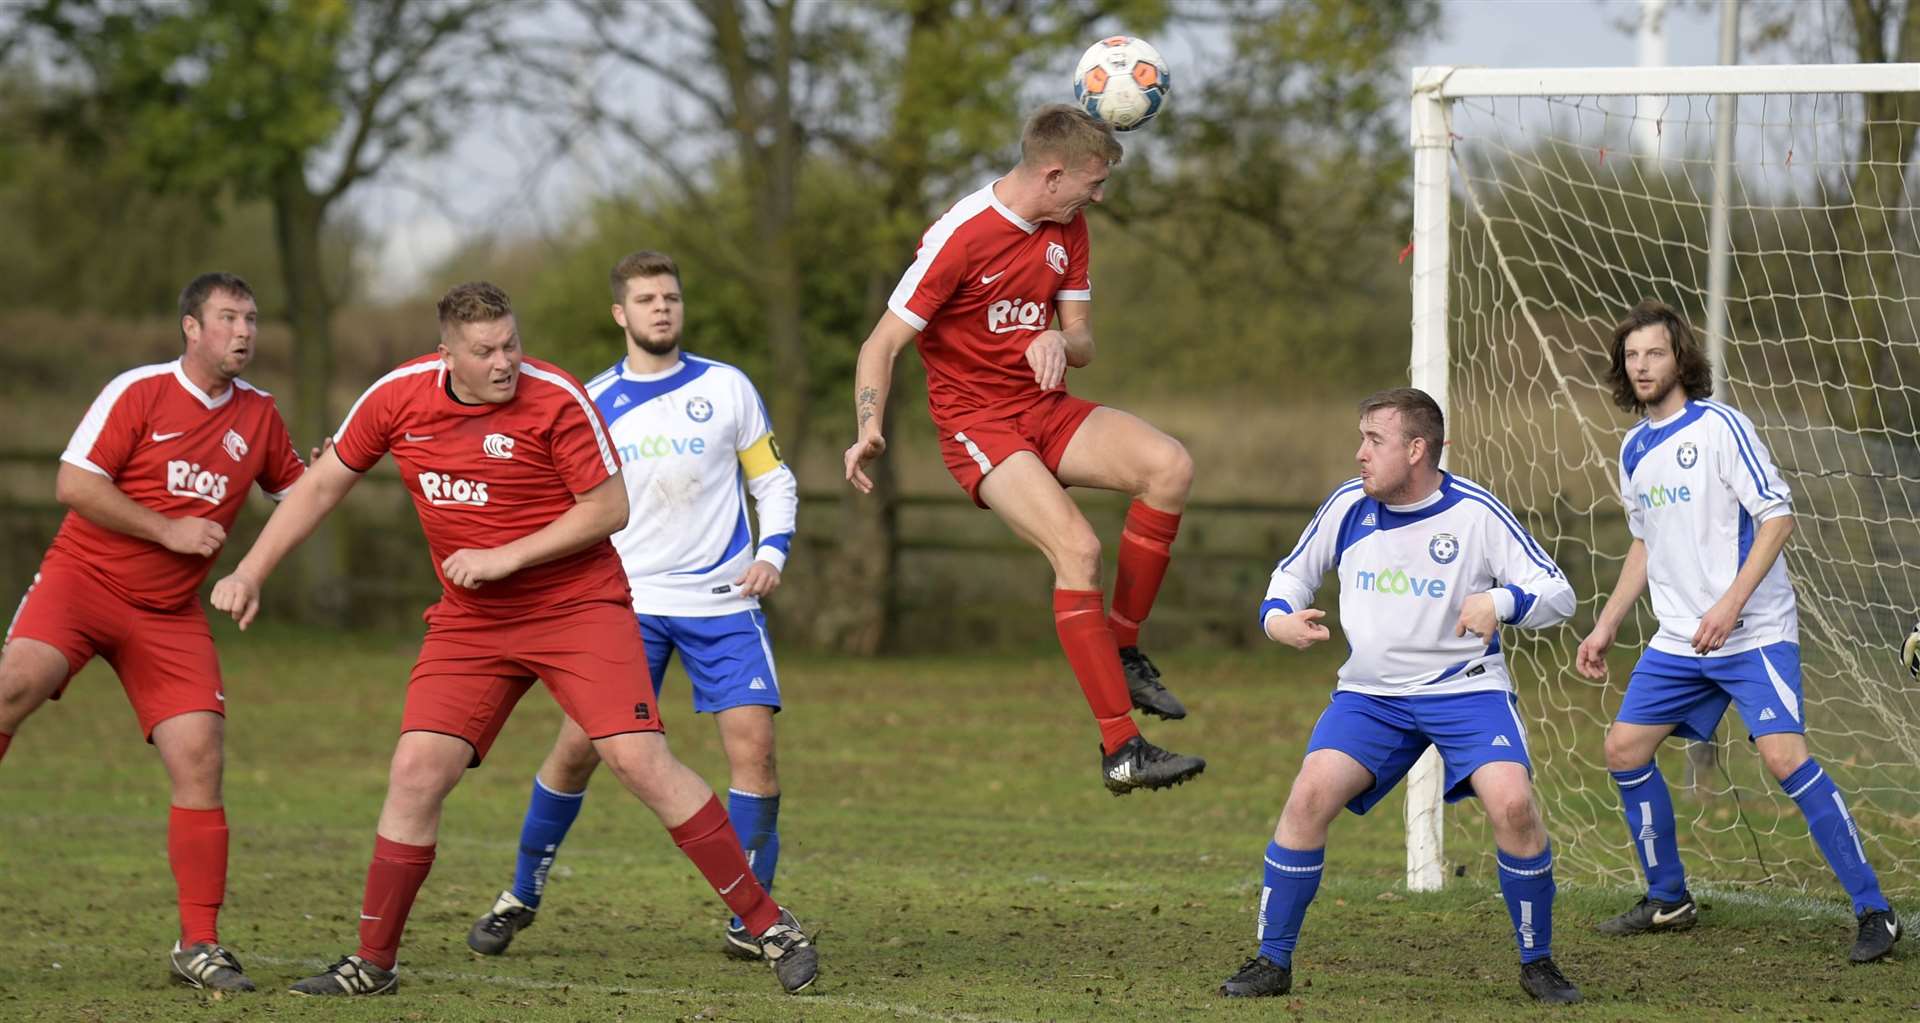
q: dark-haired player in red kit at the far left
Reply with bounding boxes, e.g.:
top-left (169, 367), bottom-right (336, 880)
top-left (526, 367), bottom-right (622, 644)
top-left (0, 273), bottom-right (303, 990)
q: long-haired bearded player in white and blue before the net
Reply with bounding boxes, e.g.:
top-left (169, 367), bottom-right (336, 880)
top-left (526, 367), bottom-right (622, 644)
top-left (1576, 299), bottom-right (1901, 964)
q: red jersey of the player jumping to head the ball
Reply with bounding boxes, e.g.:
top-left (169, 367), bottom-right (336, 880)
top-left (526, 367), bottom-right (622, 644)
top-left (887, 184), bottom-right (1092, 430)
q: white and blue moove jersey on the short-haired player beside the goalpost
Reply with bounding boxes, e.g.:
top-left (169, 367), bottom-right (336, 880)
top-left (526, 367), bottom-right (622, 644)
top-left (1260, 472), bottom-right (1574, 697)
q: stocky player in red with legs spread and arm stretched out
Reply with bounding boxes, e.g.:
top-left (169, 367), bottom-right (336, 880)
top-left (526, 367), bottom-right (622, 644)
top-left (213, 284), bottom-right (816, 994)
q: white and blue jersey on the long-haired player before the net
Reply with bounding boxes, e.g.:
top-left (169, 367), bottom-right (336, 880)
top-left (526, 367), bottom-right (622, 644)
top-left (1620, 401), bottom-right (1799, 656)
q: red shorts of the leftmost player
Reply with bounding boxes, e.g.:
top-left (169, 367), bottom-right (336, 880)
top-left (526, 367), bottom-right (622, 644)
top-left (6, 559), bottom-right (227, 743)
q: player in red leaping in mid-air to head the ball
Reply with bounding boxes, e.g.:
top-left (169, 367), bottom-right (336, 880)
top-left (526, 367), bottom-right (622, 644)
top-left (847, 104), bottom-right (1206, 795)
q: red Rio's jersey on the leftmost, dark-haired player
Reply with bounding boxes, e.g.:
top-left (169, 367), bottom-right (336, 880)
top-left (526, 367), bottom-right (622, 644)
top-left (52, 359), bottom-right (307, 610)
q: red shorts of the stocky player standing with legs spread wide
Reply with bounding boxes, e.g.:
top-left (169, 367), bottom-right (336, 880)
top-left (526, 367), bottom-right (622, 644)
top-left (399, 603), bottom-right (664, 768)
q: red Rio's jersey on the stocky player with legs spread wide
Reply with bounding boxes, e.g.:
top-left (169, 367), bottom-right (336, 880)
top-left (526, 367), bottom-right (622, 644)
top-left (334, 355), bottom-right (630, 614)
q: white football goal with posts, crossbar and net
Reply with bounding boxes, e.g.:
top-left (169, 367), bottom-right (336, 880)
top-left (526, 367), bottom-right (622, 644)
top-left (1409, 65), bottom-right (1920, 902)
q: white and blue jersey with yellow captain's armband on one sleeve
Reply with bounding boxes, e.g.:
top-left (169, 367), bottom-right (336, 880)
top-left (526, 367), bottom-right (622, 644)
top-left (588, 355), bottom-right (799, 618)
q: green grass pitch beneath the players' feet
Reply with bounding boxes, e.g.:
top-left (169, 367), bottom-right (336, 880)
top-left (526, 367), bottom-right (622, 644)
top-left (0, 628), bottom-right (1920, 1023)
